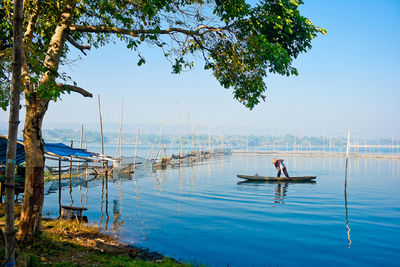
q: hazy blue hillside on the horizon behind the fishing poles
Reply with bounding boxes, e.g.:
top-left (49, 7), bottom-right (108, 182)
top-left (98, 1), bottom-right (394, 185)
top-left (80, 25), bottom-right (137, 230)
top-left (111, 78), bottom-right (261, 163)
top-left (0, 122), bottom-right (400, 147)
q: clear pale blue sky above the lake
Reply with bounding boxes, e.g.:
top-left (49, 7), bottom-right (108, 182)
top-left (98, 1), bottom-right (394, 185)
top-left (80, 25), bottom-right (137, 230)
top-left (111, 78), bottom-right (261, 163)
top-left (0, 0), bottom-right (400, 138)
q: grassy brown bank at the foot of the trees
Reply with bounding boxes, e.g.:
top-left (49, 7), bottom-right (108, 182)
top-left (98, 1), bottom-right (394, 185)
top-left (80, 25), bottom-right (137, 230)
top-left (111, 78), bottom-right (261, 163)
top-left (0, 207), bottom-right (194, 267)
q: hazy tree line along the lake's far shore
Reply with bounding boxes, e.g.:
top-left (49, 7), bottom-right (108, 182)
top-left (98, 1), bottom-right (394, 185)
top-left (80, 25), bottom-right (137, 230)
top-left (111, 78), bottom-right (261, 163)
top-left (32, 129), bottom-right (399, 148)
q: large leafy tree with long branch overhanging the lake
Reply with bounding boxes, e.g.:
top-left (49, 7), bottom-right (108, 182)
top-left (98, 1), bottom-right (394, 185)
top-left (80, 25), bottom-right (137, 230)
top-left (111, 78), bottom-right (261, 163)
top-left (0, 0), bottom-right (325, 241)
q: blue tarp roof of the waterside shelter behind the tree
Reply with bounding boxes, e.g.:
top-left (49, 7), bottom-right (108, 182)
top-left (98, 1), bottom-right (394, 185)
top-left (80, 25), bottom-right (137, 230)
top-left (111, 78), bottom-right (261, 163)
top-left (0, 135), bottom-right (111, 165)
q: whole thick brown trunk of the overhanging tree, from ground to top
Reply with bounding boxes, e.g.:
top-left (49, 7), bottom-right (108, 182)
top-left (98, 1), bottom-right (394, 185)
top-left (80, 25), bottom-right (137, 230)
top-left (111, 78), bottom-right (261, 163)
top-left (18, 0), bottom-right (76, 240)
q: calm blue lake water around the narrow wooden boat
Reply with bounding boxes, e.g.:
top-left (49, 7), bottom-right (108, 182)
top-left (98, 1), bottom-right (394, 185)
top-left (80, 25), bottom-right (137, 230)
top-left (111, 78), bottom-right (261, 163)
top-left (43, 156), bottom-right (400, 266)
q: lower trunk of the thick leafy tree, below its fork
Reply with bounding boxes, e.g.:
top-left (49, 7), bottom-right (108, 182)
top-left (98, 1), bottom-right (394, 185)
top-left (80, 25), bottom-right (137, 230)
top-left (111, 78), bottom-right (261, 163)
top-left (19, 100), bottom-right (48, 240)
